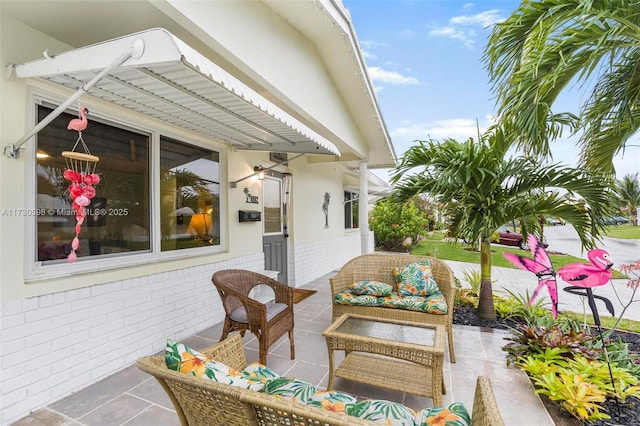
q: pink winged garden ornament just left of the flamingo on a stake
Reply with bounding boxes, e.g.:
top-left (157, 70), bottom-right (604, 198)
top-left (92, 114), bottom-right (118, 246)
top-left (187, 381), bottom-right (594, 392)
top-left (503, 234), bottom-right (558, 319)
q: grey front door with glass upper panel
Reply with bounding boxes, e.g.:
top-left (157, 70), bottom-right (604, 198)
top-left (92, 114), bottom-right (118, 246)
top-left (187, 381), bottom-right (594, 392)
top-left (262, 172), bottom-right (287, 284)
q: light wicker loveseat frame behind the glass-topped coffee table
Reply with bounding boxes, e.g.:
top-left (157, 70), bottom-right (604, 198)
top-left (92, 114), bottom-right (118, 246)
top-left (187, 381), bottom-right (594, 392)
top-left (330, 253), bottom-right (456, 362)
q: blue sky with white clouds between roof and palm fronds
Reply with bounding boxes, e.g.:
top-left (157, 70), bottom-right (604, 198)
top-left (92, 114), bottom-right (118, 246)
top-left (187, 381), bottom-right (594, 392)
top-left (343, 0), bottom-right (640, 179)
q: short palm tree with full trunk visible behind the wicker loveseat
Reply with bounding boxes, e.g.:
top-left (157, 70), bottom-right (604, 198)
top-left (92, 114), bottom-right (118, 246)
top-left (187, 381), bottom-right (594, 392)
top-left (391, 128), bottom-right (611, 320)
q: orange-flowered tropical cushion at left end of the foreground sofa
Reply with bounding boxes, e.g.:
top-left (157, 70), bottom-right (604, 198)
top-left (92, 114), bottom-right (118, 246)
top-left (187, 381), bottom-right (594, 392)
top-left (164, 339), bottom-right (264, 391)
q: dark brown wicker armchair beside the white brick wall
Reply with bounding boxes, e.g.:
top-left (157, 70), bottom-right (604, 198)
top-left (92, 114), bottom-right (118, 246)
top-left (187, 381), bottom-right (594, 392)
top-left (211, 269), bottom-right (295, 365)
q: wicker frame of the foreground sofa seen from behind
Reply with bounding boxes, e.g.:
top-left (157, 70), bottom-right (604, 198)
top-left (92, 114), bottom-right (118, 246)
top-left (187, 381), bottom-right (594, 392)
top-left (137, 334), bottom-right (504, 426)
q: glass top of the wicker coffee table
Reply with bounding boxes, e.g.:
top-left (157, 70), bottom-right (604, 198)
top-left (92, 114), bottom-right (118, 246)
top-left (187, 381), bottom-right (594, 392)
top-left (335, 317), bottom-right (436, 346)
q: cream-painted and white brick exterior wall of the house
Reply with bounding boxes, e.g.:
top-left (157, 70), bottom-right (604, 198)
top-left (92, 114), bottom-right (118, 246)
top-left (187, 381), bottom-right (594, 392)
top-left (0, 2), bottom-right (380, 424)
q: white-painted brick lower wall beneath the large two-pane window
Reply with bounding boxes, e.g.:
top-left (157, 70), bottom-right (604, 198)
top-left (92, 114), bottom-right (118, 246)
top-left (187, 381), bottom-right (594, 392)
top-left (0, 250), bottom-right (262, 425)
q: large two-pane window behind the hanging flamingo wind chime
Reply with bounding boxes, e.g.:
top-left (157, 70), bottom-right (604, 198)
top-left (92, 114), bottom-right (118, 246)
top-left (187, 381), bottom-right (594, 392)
top-left (35, 105), bottom-right (220, 265)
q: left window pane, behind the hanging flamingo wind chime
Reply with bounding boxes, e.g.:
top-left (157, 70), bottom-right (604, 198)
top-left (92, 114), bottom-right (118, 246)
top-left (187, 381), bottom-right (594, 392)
top-left (36, 105), bottom-right (151, 262)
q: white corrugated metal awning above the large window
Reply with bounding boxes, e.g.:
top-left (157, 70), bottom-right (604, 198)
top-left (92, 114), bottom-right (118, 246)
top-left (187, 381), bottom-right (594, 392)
top-left (15, 28), bottom-right (340, 155)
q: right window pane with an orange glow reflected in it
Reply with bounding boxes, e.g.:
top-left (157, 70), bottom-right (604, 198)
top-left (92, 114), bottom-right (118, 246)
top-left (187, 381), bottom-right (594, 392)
top-left (160, 136), bottom-right (220, 251)
